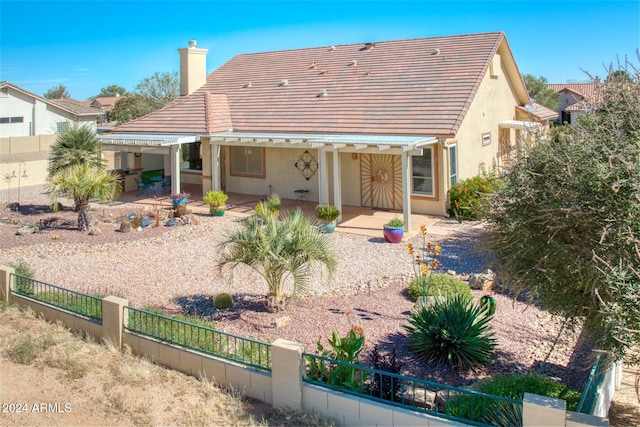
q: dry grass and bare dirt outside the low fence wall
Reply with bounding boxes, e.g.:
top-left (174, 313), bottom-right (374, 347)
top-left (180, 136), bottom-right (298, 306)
top-left (0, 305), bottom-right (335, 426)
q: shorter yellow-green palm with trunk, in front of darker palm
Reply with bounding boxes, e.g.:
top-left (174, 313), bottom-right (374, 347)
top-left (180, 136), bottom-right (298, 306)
top-left (49, 163), bottom-right (121, 231)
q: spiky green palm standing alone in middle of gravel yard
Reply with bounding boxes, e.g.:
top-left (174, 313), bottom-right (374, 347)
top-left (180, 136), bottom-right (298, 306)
top-left (218, 209), bottom-right (337, 312)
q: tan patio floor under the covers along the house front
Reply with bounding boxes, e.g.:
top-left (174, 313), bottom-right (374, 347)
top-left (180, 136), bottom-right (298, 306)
top-left (112, 184), bottom-right (442, 241)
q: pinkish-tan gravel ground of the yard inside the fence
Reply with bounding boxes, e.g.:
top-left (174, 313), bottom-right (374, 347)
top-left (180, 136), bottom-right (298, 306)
top-left (0, 189), bottom-right (591, 389)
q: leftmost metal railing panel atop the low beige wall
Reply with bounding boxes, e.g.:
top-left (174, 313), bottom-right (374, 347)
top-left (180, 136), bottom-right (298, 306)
top-left (10, 273), bottom-right (102, 320)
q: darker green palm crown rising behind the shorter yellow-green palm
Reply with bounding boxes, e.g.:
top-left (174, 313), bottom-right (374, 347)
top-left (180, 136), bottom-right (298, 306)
top-left (48, 126), bottom-right (104, 178)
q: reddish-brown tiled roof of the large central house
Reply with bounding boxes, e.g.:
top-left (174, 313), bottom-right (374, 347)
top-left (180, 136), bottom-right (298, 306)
top-left (114, 33), bottom-right (528, 136)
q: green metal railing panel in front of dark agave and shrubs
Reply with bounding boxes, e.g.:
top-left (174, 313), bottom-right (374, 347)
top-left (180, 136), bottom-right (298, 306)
top-left (304, 353), bottom-right (522, 427)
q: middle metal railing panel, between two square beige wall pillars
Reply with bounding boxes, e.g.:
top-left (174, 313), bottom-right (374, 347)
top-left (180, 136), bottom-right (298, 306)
top-left (124, 307), bottom-right (271, 371)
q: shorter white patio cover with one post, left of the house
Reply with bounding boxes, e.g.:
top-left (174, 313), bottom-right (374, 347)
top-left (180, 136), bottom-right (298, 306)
top-left (98, 134), bottom-right (200, 194)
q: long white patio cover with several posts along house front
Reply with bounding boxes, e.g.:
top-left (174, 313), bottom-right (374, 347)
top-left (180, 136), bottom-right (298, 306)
top-left (208, 132), bottom-right (438, 231)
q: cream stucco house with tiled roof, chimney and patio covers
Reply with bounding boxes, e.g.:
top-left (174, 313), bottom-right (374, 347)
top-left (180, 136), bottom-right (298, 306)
top-left (100, 32), bottom-right (555, 228)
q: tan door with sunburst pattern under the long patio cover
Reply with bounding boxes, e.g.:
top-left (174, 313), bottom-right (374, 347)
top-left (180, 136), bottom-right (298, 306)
top-left (360, 154), bottom-right (402, 210)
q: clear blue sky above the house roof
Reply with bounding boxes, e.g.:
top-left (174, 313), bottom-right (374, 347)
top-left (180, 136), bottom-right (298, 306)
top-left (0, 0), bottom-right (640, 99)
